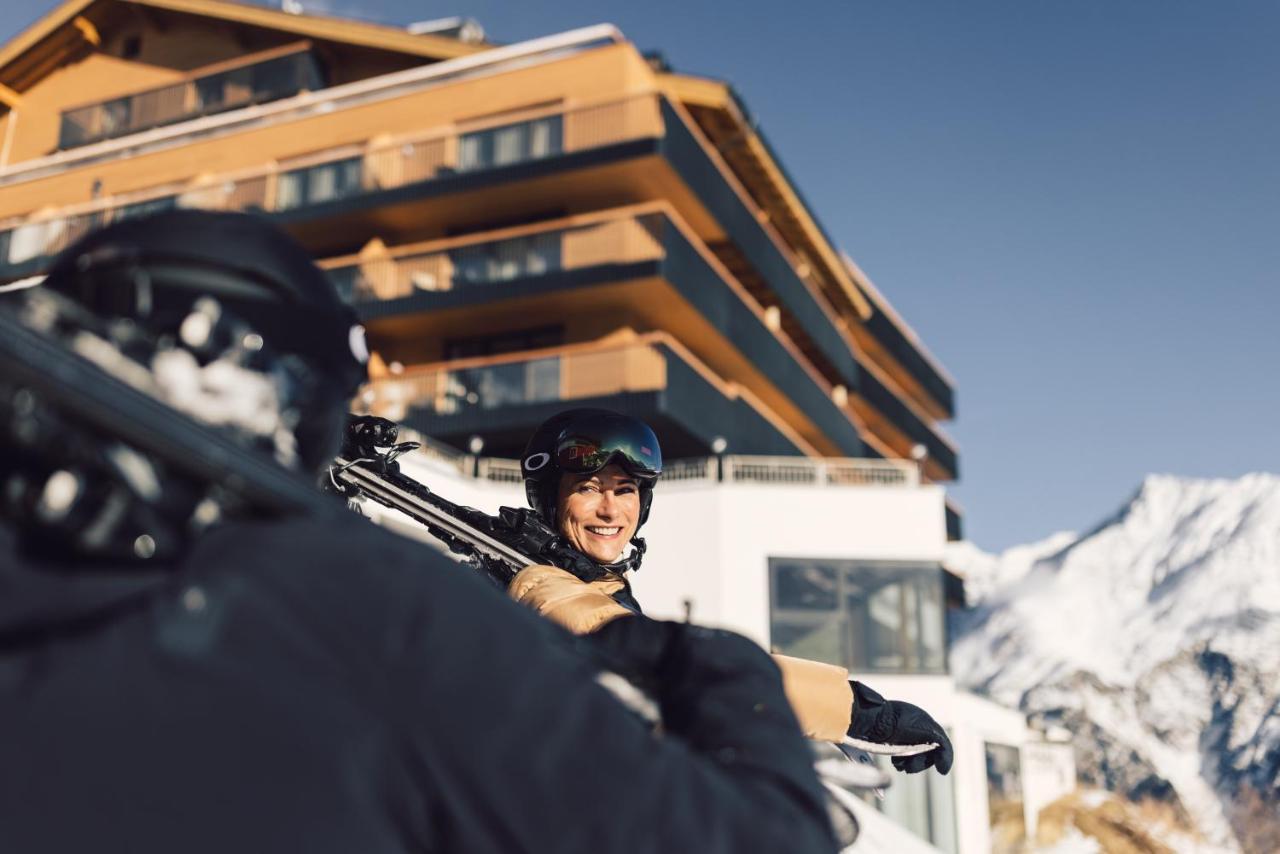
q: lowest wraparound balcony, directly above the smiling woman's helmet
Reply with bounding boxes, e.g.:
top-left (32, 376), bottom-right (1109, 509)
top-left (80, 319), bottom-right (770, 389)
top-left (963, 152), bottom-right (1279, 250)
top-left (357, 333), bottom-right (797, 457)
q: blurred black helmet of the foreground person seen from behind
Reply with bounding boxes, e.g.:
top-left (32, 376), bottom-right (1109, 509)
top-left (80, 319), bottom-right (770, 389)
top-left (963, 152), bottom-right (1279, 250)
top-left (45, 210), bottom-right (367, 470)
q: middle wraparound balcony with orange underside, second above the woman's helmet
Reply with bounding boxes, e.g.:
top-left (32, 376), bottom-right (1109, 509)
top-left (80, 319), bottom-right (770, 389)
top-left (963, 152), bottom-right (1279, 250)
top-left (324, 204), bottom-right (863, 456)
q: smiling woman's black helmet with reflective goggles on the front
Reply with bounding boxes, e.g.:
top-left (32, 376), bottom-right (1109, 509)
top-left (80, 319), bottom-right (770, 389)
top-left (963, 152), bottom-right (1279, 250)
top-left (520, 408), bottom-right (662, 531)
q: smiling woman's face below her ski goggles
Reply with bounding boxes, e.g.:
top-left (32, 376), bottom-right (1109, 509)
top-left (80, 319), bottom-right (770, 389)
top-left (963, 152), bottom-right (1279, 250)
top-left (556, 466), bottom-right (640, 563)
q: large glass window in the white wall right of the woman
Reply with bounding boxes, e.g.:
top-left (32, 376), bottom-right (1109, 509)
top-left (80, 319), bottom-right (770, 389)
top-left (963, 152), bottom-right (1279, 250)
top-left (769, 558), bottom-right (946, 673)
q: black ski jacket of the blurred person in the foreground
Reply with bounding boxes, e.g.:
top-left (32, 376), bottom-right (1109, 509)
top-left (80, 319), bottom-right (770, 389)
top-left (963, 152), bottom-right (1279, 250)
top-left (0, 513), bottom-right (835, 854)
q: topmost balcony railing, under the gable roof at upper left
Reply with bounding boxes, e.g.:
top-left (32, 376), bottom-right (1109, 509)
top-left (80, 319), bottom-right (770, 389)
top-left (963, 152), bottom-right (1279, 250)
top-left (58, 49), bottom-right (325, 150)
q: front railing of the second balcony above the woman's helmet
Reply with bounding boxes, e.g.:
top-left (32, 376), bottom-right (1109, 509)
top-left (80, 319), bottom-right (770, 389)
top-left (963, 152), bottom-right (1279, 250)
top-left (325, 214), bottom-right (667, 303)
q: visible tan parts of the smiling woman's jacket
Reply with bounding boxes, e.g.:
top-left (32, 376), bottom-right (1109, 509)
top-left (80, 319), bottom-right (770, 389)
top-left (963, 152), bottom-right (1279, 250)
top-left (507, 566), bottom-right (854, 741)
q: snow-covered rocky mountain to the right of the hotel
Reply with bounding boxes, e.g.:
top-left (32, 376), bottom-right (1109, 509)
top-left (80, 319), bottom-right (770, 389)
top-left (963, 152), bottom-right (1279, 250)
top-left (948, 475), bottom-right (1280, 851)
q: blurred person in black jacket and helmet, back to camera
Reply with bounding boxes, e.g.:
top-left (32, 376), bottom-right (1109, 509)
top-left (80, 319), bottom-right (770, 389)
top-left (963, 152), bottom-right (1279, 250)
top-left (0, 211), bottom-right (836, 854)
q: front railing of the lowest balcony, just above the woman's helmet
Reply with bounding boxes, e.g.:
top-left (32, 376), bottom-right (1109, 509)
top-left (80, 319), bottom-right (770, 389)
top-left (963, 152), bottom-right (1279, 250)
top-left (360, 344), bottom-right (669, 421)
